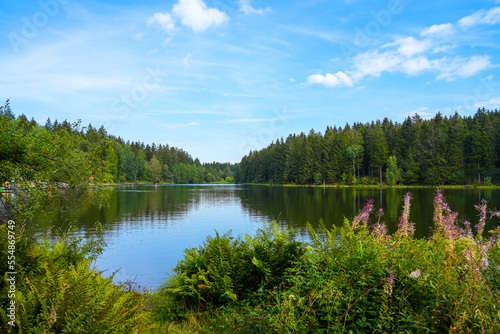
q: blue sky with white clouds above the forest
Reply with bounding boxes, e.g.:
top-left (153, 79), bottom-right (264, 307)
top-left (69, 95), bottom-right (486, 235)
top-left (0, 0), bottom-right (500, 163)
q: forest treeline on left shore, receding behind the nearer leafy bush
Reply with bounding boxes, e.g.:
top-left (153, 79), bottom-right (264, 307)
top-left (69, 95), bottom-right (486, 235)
top-left (0, 101), bottom-right (234, 183)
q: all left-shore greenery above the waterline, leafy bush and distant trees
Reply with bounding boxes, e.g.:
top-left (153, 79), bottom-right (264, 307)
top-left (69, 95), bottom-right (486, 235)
top-left (0, 101), bottom-right (234, 185)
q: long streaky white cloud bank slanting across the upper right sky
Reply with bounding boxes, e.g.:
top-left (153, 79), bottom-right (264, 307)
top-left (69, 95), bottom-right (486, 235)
top-left (307, 9), bottom-right (494, 87)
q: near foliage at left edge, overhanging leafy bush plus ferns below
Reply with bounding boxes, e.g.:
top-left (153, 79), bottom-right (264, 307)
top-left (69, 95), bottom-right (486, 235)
top-left (0, 103), bottom-right (150, 333)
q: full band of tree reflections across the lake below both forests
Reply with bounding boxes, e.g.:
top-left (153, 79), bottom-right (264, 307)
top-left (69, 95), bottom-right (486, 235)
top-left (36, 185), bottom-right (500, 237)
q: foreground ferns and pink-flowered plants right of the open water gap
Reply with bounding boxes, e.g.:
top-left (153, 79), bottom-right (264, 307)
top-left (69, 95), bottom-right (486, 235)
top-left (160, 192), bottom-right (500, 333)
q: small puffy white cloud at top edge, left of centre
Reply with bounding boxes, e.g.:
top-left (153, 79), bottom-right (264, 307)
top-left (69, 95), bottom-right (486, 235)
top-left (172, 0), bottom-right (229, 32)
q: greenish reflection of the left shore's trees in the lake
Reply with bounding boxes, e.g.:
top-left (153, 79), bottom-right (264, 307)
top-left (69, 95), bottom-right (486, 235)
top-left (36, 185), bottom-right (242, 230)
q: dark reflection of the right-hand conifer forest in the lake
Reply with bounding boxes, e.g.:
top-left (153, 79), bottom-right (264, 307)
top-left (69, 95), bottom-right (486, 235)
top-left (238, 186), bottom-right (500, 237)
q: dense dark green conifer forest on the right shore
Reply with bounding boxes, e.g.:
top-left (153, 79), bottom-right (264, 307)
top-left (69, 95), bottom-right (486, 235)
top-left (235, 108), bottom-right (500, 185)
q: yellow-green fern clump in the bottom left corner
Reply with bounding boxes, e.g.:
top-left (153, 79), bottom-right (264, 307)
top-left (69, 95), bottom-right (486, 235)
top-left (0, 225), bottom-right (145, 333)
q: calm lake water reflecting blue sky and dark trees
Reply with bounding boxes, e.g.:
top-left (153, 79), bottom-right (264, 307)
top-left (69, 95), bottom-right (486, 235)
top-left (37, 185), bottom-right (500, 289)
